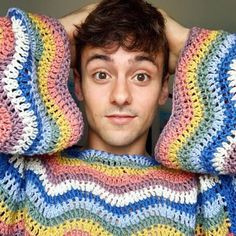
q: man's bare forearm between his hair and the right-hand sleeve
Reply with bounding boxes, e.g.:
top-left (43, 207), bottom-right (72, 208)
top-left (158, 9), bottom-right (189, 74)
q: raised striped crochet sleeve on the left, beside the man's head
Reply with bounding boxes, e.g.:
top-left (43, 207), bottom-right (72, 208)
top-left (0, 9), bottom-right (83, 155)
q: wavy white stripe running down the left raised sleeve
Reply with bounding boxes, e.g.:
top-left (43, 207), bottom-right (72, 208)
top-left (2, 17), bottom-right (38, 154)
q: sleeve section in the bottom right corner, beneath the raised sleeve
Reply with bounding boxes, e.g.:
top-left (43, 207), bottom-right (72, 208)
top-left (195, 175), bottom-right (236, 236)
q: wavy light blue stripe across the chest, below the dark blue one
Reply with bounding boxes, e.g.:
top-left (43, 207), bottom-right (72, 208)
top-left (25, 190), bottom-right (195, 228)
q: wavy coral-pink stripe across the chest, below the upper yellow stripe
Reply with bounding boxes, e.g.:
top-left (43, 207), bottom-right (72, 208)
top-left (42, 155), bottom-right (196, 191)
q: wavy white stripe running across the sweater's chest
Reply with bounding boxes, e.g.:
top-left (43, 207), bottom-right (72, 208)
top-left (27, 160), bottom-right (197, 206)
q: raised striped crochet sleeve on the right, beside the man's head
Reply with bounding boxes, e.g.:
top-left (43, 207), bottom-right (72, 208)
top-left (155, 28), bottom-right (236, 175)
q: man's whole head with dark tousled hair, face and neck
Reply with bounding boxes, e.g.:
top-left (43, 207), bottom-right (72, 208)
top-left (75, 1), bottom-right (168, 155)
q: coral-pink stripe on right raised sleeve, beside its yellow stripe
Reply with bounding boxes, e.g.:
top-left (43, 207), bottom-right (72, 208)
top-left (155, 29), bottom-right (210, 168)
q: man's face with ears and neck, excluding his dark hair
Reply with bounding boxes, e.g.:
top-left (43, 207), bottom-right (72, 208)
top-left (74, 47), bottom-right (168, 154)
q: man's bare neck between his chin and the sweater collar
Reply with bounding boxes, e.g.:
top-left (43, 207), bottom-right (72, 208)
top-left (86, 131), bottom-right (148, 155)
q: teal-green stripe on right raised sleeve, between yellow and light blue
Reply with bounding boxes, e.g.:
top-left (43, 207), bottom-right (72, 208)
top-left (177, 30), bottom-right (227, 172)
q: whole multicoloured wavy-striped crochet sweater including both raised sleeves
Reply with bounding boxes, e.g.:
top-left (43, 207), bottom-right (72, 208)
top-left (0, 9), bottom-right (236, 236)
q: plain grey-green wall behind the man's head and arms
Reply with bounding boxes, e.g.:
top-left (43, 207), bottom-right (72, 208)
top-left (0, 0), bottom-right (236, 150)
